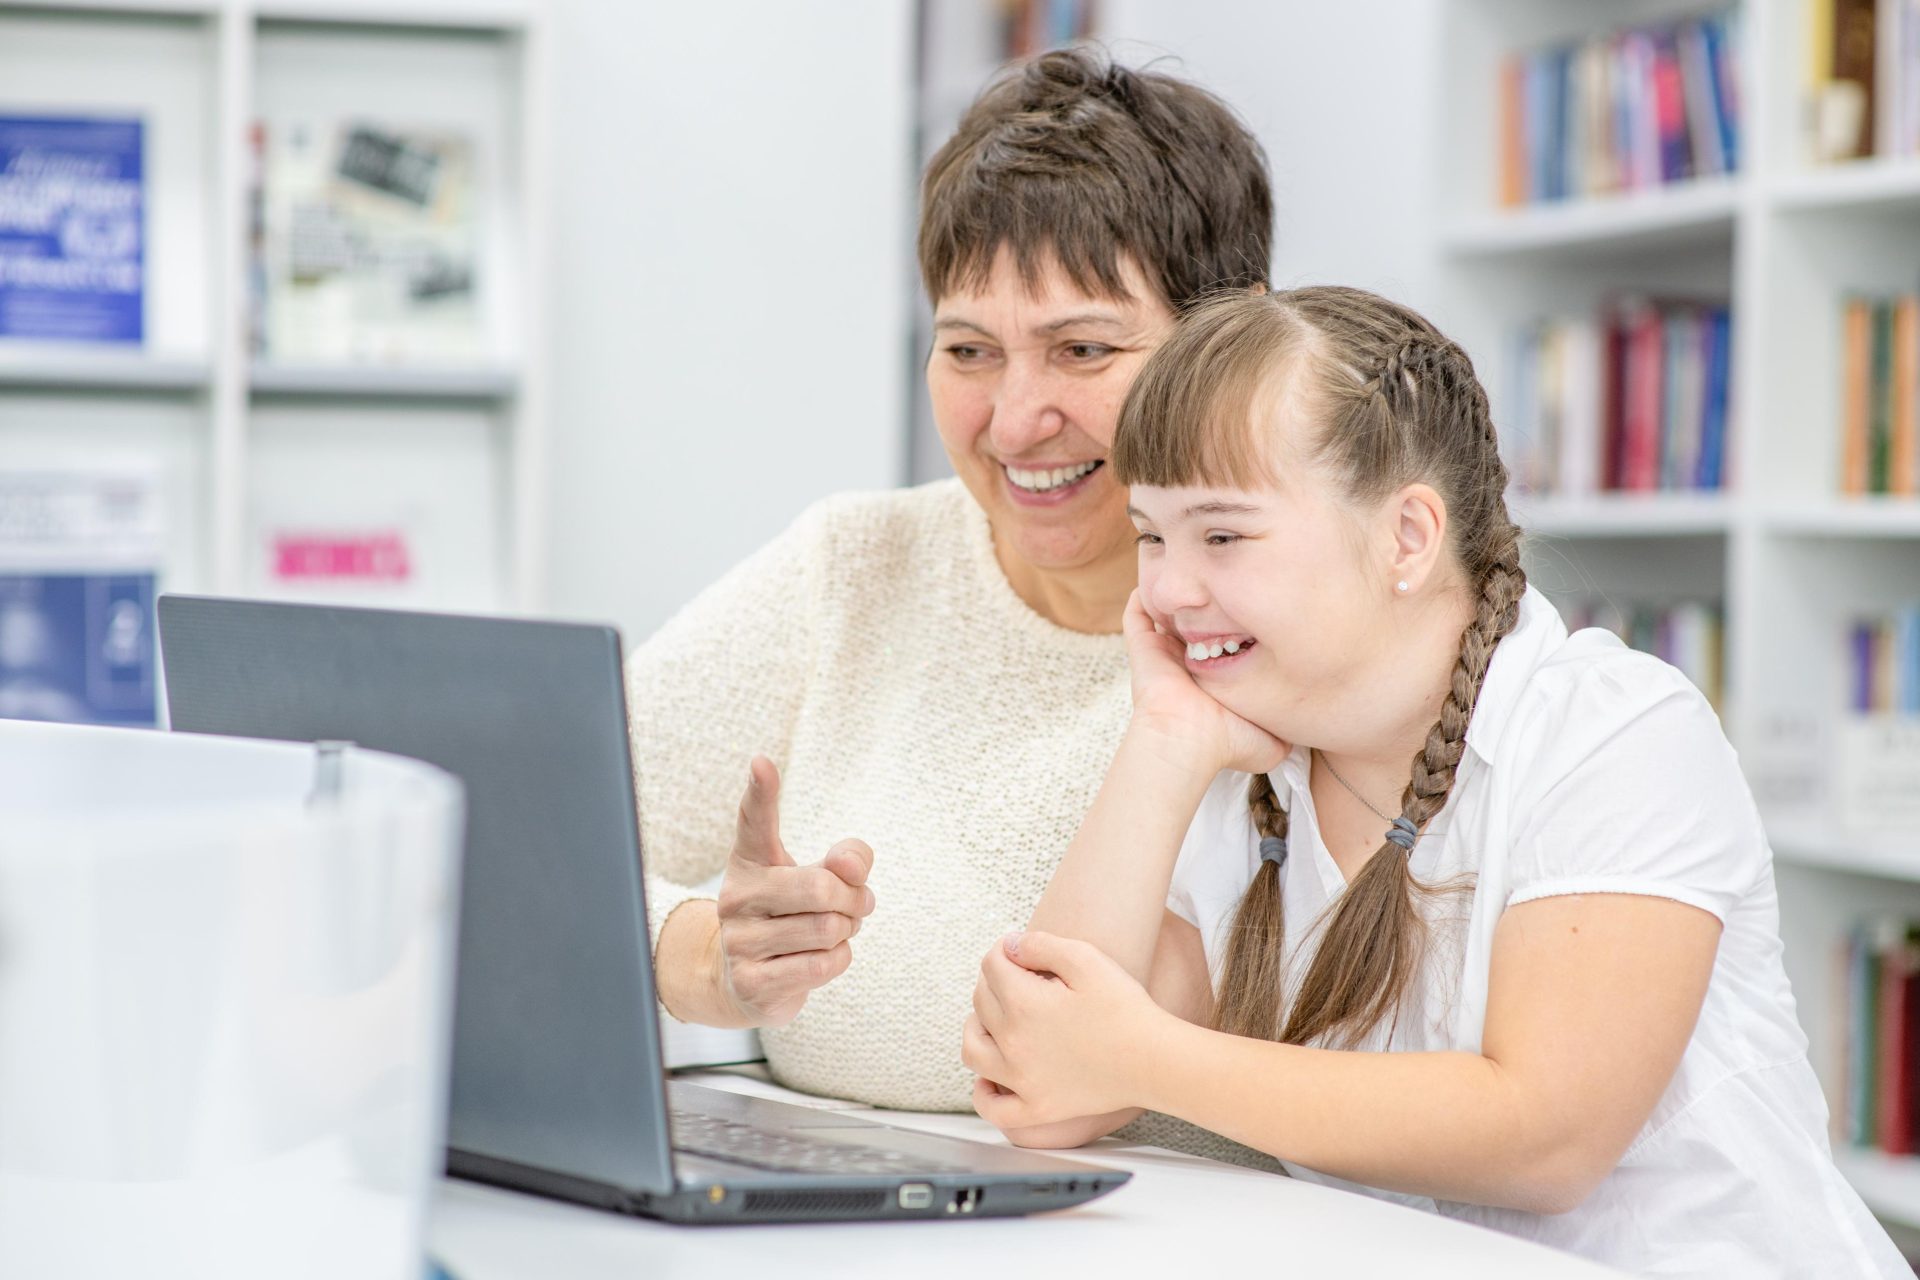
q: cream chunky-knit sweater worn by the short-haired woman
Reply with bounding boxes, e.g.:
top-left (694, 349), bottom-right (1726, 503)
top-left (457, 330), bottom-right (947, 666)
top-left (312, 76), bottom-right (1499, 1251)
top-left (628, 480), bottom-right (1129, 1111)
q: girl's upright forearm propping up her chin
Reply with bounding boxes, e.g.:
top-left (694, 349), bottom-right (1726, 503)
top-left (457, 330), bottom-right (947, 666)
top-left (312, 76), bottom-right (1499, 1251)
top-left (1029, 725), bottom-right (1215, 983)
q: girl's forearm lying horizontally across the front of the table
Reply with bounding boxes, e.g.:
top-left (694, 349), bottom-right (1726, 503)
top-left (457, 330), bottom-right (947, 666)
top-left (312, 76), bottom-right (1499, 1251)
top-left (1139, 1017), bottom-right (1605, 1213)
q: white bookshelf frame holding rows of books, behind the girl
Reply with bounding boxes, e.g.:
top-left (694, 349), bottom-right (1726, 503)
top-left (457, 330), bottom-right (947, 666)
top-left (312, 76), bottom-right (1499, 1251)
top-left (1438, 0), bottom-right (1920, 1228)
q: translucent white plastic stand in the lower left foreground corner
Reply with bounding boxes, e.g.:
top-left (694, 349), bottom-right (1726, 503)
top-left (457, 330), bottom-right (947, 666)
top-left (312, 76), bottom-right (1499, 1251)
top-left (0, 722), bottom-right (465, 1280)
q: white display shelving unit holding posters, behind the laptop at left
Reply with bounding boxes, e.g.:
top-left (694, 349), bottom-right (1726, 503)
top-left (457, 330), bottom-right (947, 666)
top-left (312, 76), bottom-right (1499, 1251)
top-left (0, 0), bottom-right (549, 610)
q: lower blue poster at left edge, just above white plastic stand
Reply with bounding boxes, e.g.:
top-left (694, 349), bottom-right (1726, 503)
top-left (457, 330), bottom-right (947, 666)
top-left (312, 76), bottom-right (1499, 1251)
top-left (0, 574), bottom-right (157, 725)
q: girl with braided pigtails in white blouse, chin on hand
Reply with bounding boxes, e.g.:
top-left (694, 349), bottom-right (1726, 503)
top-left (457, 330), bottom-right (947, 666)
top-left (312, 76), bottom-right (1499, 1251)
top-left (964, 288), bottom-right (1912, 1276)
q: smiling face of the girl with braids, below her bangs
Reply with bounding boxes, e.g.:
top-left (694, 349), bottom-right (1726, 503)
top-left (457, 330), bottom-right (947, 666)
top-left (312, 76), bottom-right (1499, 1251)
top-left (1129, 426), bottom-right (1394, 745)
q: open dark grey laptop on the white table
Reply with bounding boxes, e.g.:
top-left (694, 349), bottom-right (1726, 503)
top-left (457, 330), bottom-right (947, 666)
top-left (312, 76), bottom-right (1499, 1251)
top-left (159, 595), bottom-right (1131, 1222)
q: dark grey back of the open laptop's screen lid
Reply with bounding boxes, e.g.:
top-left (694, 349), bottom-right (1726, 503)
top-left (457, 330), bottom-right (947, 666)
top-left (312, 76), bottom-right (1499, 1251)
top-left (159, 595), bottom-right (674, 1192)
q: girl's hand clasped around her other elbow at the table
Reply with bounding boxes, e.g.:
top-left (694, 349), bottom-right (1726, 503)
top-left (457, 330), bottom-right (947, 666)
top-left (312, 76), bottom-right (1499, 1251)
top-left (960, 933), bottom-right (1173, 1130)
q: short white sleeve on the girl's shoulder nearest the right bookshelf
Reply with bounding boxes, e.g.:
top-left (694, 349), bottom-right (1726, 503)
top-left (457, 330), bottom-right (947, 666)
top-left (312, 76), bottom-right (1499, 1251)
top-left (1507, 651), bottom-right (1768, 921)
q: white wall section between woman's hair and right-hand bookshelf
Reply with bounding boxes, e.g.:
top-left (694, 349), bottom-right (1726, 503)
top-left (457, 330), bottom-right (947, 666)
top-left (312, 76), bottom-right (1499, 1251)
top-left (1100, 0), bottom-right (1444, 324)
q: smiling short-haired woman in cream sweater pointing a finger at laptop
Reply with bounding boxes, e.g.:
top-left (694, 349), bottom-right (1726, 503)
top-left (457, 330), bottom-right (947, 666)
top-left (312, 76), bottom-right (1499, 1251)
top-left (630, 50), bottom-right (1273, 1111)
